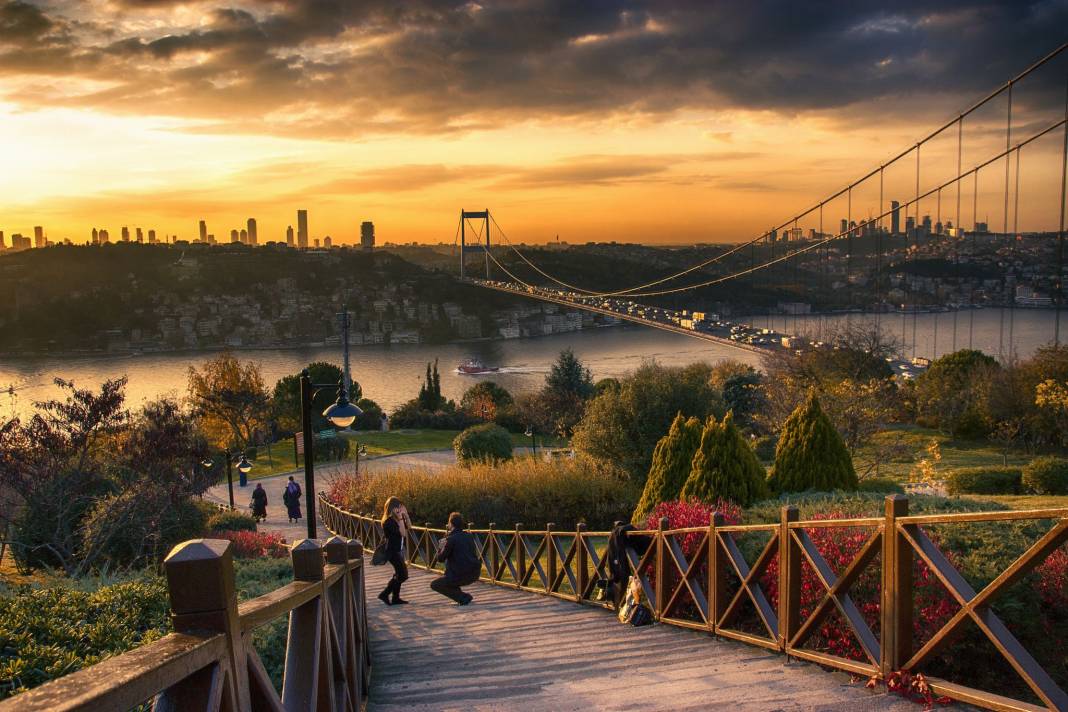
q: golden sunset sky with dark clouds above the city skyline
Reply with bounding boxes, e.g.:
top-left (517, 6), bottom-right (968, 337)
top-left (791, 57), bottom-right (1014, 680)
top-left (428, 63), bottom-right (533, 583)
top-left (0, 0), bottom-right (1068, 243)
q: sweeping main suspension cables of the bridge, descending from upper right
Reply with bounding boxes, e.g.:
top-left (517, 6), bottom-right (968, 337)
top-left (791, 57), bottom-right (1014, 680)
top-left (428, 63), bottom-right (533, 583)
top-left (482, 43), bottom-right (1068, 297)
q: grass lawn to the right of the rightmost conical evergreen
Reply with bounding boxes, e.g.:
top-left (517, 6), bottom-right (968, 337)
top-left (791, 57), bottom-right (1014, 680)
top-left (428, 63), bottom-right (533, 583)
top-left (854, 425), bottom-right (1034, 481)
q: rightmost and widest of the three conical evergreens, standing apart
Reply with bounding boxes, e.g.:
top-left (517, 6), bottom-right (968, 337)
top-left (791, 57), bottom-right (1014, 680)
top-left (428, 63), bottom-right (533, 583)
top-left (768, 392), bottom-right (858, 492)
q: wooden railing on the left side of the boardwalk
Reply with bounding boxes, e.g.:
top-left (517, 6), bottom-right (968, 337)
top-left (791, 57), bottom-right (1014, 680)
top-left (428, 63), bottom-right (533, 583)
top-left (0, 537), bottom-right (370, 712)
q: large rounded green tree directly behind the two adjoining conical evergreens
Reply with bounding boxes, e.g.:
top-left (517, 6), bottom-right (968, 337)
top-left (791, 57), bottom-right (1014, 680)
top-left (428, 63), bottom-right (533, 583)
top-left (571, 361), bottom-right (723, 485)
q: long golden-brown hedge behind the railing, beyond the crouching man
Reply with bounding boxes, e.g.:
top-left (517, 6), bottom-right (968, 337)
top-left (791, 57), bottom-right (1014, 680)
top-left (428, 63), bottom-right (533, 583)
top-left (327, 457), bottom-right (638, 529)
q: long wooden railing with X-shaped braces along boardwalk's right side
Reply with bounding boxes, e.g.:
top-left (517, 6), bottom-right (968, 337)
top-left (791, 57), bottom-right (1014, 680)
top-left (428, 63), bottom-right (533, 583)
top-left (319, 494), bottom-right (1068, 711)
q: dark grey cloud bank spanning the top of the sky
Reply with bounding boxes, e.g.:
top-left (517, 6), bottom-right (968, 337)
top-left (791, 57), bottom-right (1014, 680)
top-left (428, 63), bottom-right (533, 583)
top-left (0, 0), bottom-right (1068, 136)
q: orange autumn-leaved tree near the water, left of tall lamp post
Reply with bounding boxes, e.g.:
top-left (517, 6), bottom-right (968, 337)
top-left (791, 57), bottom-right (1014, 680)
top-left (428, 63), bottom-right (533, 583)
top-left (189, 351), bottom-right (270, 447)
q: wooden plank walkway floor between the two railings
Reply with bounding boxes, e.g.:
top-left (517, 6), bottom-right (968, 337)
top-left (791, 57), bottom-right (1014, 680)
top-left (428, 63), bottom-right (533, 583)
top-left (367, 566), bottom-right (918, 712)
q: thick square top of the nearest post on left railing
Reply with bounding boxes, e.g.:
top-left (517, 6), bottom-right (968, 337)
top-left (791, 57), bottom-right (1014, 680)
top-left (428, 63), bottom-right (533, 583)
top-left (163, 539), bottom-right (237, 615)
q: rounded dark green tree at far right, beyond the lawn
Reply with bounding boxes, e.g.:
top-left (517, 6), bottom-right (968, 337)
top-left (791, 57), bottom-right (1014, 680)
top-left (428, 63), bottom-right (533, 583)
top-left (914, 349), bottom-right (1000, 438)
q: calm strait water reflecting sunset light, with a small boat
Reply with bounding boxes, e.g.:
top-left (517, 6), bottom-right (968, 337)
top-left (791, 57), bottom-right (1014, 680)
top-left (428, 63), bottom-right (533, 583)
top-left (0, 308), bottom-right (1068, 416)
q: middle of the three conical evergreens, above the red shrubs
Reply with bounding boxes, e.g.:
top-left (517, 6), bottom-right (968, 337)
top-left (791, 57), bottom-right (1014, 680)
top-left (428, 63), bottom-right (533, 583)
top-left (679, 411), bottom-right (768, 507)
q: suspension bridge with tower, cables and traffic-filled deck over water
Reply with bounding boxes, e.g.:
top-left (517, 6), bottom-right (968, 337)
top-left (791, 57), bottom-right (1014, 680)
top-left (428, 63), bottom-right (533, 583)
top-left (456, 43), bottom-right (1068, 367)
